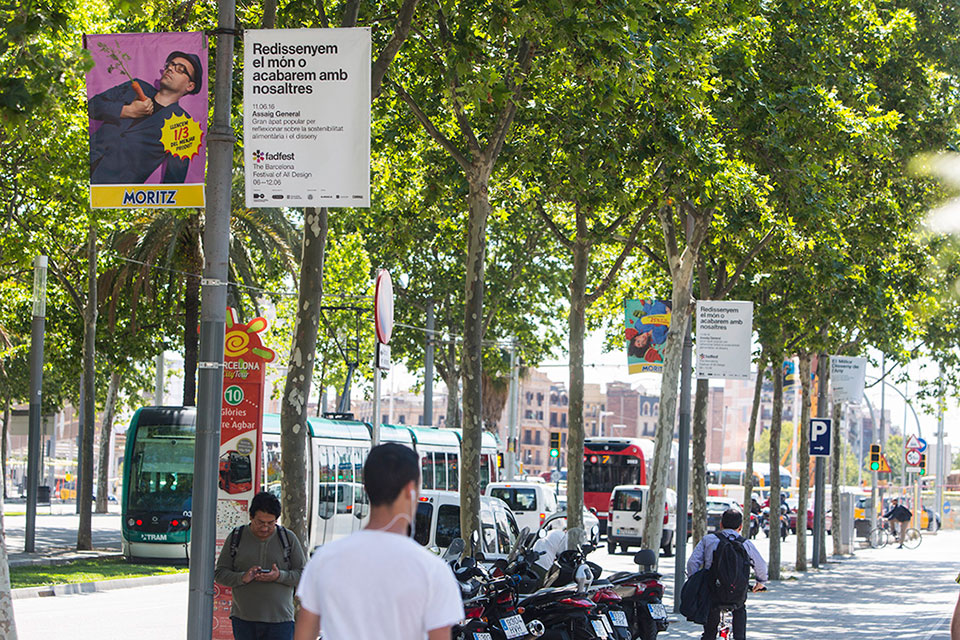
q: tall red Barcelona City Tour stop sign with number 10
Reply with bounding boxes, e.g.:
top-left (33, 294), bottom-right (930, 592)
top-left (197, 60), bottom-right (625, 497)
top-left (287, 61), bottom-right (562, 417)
top-left (211, 307), bottom-right (276, 640)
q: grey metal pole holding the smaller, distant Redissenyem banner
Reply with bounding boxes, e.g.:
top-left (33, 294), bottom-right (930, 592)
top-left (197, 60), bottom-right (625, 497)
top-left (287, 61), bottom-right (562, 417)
top-left (672, 316), bottom-right (693, 613)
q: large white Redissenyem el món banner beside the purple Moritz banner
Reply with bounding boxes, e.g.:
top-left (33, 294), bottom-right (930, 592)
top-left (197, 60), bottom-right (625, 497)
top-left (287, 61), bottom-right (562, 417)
top-left (243, 28), bottom-right (371, 207)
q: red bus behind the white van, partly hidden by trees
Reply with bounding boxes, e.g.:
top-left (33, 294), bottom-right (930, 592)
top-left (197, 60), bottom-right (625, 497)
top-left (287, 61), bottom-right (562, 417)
top-left (583, 438), bottom-right (677, 533)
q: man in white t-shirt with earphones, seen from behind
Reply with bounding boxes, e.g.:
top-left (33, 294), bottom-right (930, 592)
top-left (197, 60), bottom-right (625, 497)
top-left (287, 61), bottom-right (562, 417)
top-left (294, 443), bottom-right (463, 640)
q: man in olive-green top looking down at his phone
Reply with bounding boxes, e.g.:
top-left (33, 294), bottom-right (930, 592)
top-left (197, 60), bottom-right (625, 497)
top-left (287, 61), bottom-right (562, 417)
top-left (214, 491), bottom-right (306, 640)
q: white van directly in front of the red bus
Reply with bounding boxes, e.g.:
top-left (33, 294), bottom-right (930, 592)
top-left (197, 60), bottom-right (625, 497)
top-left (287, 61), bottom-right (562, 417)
top-left (607, 484), bottom-right (677, 557)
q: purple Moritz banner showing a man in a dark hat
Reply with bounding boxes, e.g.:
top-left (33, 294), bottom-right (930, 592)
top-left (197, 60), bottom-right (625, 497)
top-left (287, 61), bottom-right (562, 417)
top-left (83, 32), bottom-right (209, 209)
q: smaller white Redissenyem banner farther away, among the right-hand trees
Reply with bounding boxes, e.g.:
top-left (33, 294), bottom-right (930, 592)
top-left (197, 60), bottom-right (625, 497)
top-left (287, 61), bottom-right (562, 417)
top-left (696, 300), bottom-right (753, 380)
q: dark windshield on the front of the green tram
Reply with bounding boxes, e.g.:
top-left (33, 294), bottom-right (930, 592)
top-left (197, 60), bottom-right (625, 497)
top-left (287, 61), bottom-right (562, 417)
top-left (128, 424), bottom-right (195, 511)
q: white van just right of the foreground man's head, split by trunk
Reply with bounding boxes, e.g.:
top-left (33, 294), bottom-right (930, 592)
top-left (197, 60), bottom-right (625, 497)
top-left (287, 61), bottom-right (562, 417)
top-left (413, 490), bottom-right (520, 560)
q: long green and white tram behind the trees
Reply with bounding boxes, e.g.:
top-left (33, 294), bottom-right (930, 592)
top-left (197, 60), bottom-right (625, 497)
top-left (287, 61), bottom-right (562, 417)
top-left (121, 407), bottom-right (498, 561)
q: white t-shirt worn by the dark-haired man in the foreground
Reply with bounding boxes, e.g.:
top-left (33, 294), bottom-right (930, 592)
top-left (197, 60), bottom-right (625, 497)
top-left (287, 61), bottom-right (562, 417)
top-left (297, 529), bottom-right (464, 640)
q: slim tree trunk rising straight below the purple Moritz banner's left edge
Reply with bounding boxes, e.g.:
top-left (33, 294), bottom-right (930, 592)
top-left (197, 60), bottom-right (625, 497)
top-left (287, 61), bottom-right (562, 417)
top-left (77, 224), bottom-right (97, 551)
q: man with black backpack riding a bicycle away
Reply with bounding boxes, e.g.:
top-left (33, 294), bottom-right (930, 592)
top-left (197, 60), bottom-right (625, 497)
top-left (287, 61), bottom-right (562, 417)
top-left (686, 509), bottom-right (767, 640)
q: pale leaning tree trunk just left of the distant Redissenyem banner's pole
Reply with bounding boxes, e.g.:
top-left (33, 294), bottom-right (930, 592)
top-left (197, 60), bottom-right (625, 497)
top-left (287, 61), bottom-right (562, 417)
top-left (642, 272), bottom-right (691, 549)
